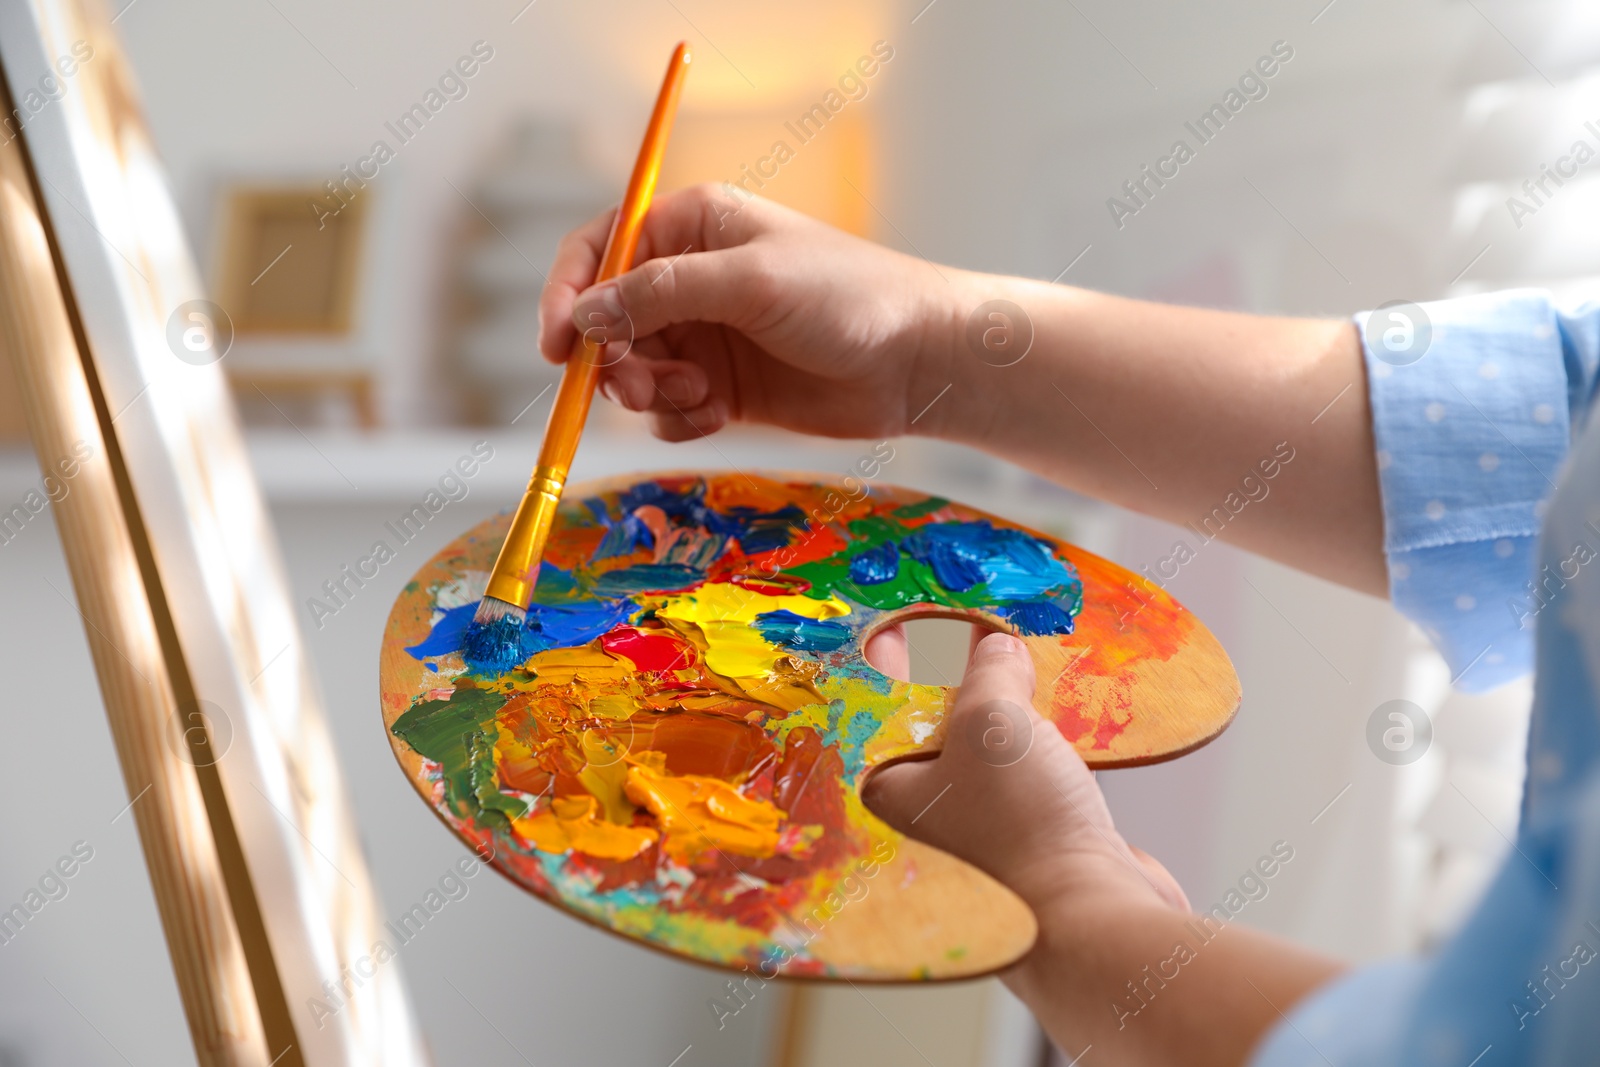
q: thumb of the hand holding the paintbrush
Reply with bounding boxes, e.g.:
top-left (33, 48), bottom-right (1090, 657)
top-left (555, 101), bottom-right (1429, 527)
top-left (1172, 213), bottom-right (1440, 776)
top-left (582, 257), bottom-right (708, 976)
top-left (573, 248), bottom-right (773, 342)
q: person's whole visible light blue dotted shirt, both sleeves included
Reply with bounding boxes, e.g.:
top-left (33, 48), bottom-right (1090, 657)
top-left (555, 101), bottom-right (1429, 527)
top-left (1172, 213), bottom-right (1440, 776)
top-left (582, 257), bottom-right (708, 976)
top-left (1251, 291), bottom-right (1600, 1067)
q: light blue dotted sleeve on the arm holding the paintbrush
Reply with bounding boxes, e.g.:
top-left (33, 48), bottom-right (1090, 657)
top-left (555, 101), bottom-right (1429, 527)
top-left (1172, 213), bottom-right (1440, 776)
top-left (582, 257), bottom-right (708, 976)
top-left (1355, 290), bottom-right (1600, 689)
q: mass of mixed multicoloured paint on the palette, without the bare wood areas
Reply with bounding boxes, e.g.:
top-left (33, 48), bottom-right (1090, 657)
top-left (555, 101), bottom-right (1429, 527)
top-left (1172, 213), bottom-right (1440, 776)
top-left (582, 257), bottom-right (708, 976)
top-left (386, 474), bottom-right (1222, 974)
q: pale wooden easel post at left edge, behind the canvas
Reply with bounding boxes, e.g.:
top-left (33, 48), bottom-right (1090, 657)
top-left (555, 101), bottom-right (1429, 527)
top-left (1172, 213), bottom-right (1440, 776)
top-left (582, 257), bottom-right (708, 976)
top-left (0, 77), bottom-right (283, 1067)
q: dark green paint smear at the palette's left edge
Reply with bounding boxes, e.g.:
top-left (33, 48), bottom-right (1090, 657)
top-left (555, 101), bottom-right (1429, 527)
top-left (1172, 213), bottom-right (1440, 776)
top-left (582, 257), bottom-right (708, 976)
top-left (389, 688), bottom-right (528, 830)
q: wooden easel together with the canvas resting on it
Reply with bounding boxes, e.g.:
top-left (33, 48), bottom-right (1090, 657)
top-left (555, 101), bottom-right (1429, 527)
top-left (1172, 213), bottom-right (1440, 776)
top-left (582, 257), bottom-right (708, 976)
top-left (0, 0), bottom-right (427, 1067)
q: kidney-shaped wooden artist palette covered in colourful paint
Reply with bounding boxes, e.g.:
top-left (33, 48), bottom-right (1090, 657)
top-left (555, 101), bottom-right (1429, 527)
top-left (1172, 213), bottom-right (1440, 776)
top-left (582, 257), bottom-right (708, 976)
top-left (381, 472), bottom-right (1240, 981)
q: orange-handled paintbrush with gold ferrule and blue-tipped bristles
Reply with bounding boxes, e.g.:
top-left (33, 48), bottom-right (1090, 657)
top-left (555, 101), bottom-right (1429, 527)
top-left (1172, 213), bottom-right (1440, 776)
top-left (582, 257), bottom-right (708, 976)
top-left (462, 42), bottom-right (690, 672)
